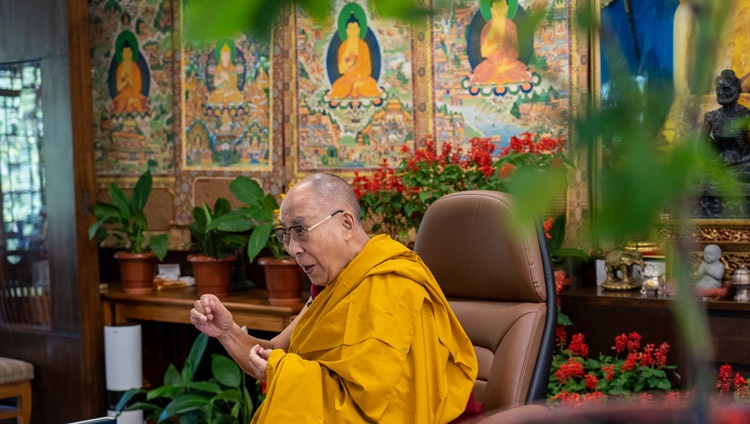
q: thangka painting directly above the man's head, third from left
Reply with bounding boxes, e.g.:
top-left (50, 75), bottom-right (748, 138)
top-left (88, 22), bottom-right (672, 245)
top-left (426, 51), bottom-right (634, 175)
top-left (295, 0), bottom-right (414, 173)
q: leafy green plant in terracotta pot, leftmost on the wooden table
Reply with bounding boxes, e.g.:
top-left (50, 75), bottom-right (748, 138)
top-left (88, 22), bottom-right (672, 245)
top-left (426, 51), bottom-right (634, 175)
top-left (89, 170), bottom-right (169, 293)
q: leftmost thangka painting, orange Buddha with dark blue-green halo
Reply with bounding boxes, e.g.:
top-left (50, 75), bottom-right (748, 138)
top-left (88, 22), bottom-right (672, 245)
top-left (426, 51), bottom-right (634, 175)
top-left (89, 0), bottom-right (174, 175)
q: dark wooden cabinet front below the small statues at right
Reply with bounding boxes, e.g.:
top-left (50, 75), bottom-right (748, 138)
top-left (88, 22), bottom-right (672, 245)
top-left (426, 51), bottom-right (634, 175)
top-left (559, 287), bottom-right (750, 381)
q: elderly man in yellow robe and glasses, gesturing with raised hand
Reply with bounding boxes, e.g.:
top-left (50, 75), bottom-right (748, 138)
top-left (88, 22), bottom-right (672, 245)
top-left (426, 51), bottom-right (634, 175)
top-left (190, 174), bottom-right (477, 423)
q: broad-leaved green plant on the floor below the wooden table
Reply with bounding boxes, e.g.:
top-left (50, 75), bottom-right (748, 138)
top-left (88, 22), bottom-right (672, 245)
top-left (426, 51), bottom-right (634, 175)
top-left (115, 333), bottom-right (260, 423)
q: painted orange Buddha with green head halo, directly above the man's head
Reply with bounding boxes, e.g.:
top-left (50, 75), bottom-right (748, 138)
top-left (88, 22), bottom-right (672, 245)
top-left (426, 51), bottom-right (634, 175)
top-left (326, 3), bottom-right (384, 107)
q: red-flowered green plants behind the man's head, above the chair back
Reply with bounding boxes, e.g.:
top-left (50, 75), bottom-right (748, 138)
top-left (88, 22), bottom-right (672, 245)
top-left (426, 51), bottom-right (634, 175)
top-left (352, 132), bottom-right (568, 242)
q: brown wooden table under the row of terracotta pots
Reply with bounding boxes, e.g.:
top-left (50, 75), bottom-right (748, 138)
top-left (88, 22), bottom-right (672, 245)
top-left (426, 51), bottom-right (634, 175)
top-left (101, 285), bottom-right (303, 333)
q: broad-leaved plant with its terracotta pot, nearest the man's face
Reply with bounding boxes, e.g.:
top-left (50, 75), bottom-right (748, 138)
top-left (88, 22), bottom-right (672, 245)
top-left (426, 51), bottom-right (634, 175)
top-left (213, 176), bottom-right (303, 306)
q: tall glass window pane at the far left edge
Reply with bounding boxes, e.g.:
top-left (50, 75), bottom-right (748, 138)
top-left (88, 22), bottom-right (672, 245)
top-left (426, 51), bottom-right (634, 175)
top-left (0, 62), bottom-right (50, 329)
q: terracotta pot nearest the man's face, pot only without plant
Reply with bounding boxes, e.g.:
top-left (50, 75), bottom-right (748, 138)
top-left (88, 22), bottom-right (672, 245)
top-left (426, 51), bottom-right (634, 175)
top-left (258, 257), bottom-right (303, 306)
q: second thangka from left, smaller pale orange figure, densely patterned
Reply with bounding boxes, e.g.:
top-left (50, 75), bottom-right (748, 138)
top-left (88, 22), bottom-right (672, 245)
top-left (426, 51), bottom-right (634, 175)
top-left (182, 10), bottom-right (273, 171)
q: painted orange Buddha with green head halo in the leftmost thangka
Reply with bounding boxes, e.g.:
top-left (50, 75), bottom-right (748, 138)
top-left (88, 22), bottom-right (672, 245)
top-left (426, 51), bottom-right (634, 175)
top-left (110, 31), bottom-right (148, 113)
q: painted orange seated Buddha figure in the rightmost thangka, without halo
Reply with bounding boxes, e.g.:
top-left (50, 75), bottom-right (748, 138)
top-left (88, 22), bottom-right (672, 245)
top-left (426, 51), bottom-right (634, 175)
top-left (470, 0), bottom-right (531, 85)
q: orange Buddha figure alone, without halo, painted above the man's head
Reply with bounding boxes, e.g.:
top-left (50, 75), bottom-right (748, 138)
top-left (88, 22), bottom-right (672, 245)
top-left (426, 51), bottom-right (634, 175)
top-left (330, 12), bottom-right (381, 99)
